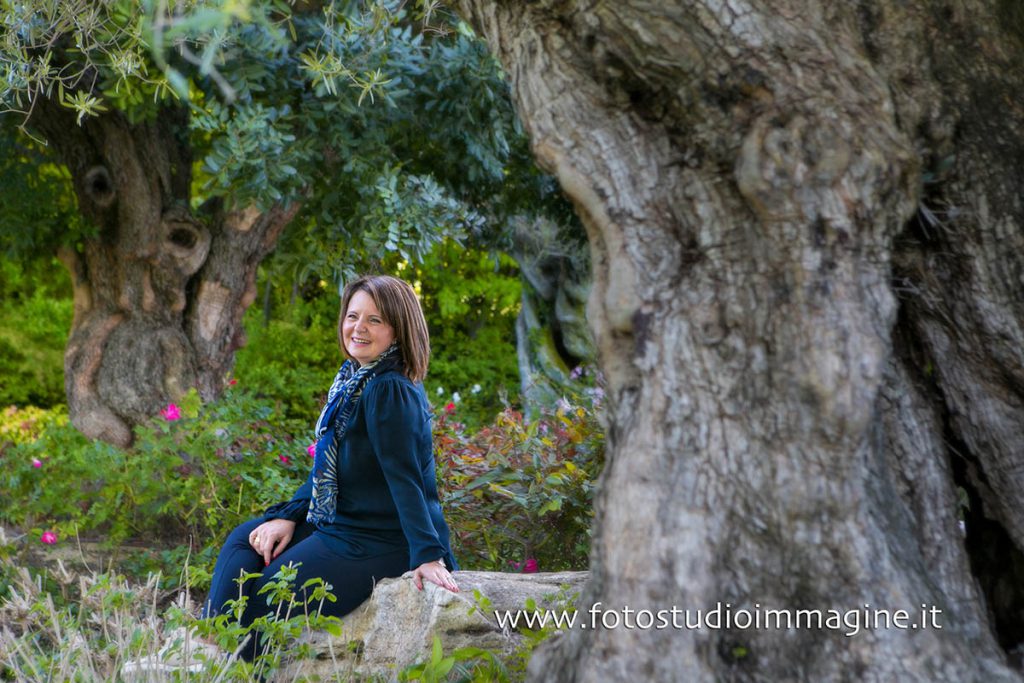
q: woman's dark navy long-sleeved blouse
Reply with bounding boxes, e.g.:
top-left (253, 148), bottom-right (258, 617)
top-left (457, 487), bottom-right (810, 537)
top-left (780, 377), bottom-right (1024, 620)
top-left (264, 371), bottom-right (458, 570)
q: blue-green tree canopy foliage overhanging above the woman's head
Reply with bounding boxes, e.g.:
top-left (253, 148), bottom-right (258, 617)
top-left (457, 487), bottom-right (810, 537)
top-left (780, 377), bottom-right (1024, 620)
top-left (0, 0), bottom-right (571, 282)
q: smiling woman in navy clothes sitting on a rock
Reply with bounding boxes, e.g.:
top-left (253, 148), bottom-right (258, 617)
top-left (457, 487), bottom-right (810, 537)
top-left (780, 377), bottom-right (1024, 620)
top-left (204, 275), bottom-right (459, 659)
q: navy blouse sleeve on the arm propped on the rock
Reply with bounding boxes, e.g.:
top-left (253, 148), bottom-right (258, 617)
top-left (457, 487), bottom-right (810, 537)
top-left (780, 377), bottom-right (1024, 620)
top-left (362, 380), bottom-right (447, 567)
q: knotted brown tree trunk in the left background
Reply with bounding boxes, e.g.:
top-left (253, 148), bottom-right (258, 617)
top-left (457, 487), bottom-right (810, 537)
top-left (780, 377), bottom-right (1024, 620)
top-left (29, 99), bottom-right (298, 446)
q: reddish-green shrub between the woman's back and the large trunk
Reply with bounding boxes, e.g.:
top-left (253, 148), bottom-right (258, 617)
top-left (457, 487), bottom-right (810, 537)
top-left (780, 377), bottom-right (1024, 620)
top-left (434, 387), bottom-right (604, 572)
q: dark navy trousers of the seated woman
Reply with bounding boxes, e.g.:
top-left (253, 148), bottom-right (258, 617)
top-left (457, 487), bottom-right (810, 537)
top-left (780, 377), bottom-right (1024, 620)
top-left (203, 517), bottom-right (409, 661)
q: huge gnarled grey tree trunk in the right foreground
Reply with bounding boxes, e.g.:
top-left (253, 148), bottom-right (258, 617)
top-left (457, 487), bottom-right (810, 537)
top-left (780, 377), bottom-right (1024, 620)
top-left (459, 0), bottom-right (1024, 681)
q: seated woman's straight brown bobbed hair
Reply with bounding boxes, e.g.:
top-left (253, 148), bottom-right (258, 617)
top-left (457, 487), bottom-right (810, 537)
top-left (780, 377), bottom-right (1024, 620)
top-left (338, 275), bottom-right (430, 382)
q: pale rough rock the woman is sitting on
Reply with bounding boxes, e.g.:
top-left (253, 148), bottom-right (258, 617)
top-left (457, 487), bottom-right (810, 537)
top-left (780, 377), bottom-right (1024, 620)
top-left (280, 571), bottom-right (588, 681)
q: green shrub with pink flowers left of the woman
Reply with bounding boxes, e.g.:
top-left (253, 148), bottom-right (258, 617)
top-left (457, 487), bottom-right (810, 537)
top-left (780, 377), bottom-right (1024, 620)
top-left (0, 389), bottom-right (308, 574)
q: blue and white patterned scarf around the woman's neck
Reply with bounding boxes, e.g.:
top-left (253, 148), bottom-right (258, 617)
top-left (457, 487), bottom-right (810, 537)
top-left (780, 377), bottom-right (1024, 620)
top-left (306, 343), bottom-right (401, 524)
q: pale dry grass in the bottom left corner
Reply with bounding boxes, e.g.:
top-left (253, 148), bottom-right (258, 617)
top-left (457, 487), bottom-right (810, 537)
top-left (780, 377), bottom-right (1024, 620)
top-left (0, 529), bottom-right (350, 683)
